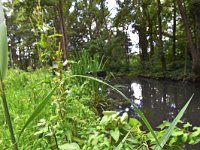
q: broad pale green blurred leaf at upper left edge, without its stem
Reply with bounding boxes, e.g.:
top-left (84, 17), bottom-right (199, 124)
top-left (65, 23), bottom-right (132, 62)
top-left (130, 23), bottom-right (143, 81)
top-left (0, 2), bottom-right (8, 80)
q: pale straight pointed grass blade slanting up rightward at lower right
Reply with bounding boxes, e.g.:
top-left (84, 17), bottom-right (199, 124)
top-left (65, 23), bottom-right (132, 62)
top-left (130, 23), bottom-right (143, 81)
top-left (155, 94), bottom-right (194, 150)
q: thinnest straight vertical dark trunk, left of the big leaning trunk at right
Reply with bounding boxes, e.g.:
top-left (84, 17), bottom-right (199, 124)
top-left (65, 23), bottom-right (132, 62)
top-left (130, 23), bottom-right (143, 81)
top-left (172, 0), bottom-right (176, 61)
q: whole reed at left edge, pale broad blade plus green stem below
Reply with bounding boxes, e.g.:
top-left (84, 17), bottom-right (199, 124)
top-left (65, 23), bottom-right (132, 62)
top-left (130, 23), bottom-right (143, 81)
top-left (0, 0), bottom-right (18, 150)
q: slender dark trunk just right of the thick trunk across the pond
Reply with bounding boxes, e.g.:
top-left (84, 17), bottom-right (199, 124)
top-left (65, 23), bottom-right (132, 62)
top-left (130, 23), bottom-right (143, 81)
top-left (157, 0), bottom-right (166, 71)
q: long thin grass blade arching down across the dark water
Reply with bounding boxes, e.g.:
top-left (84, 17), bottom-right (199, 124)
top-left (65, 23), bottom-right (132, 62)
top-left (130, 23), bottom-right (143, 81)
top-left (73, 75), bottom-right (160, 145)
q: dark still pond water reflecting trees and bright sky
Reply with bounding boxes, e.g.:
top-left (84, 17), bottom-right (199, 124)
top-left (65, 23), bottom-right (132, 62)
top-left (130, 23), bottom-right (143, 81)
top-left (111, 78), bottom-right (200, 127)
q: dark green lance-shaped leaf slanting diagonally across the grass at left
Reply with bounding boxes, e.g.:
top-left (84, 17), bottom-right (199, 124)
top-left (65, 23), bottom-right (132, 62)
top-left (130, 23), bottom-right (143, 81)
top-left (19, 86), bottom-right (58, 138)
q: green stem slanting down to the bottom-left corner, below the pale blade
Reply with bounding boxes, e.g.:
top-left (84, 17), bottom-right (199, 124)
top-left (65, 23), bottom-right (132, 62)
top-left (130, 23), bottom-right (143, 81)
top-left (0, 80), bottom-right (18, 150)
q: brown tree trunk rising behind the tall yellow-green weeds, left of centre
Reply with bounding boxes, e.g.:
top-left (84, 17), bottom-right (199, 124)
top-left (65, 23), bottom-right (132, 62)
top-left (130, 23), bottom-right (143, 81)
top-left (58, 0), bottom-right (68, 60)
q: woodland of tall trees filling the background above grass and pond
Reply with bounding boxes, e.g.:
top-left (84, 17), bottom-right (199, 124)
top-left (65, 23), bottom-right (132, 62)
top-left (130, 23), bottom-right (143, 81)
top-left (4, 0), bottom-right (200, 80)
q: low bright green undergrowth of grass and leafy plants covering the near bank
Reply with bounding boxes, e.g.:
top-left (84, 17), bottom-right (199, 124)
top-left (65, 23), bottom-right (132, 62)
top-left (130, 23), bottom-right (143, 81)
top-left (0, 70), bottom-right (200, 149)
